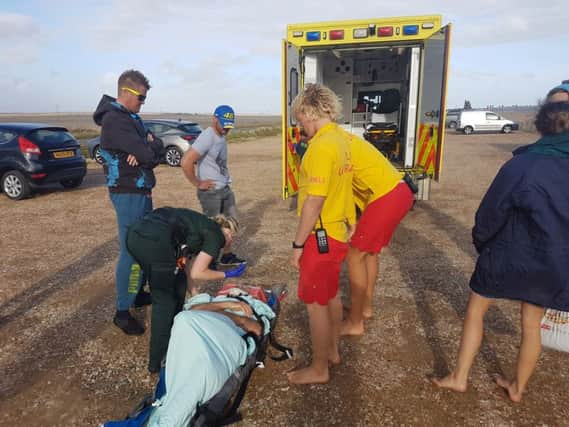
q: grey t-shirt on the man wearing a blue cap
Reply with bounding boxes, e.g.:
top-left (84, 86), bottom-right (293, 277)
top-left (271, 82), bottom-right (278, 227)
top-left (192, 127), bottom-right (231, 189)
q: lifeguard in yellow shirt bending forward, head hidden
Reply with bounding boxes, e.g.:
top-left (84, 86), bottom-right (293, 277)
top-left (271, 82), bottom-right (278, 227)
top-left (341, 132), bottom-right (413, 335)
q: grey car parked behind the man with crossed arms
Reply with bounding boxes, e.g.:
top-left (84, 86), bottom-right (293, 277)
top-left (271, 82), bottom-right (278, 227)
top-left (87, 119), bottom-right (202, 166)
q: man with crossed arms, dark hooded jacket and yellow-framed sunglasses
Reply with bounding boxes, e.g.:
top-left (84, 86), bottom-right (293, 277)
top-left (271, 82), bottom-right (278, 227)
top-left (93, 70), bottom-right (164, 335)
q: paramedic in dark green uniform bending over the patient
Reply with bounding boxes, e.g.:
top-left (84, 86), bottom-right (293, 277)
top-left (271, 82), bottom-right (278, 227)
top-left (126, 207), bottom-right (246, 372)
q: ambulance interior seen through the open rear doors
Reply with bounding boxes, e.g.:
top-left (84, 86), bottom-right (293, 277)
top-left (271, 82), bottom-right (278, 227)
top-left (304, 47), bottom-right (411, 165)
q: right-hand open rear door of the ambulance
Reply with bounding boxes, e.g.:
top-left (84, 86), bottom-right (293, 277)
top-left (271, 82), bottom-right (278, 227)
top-left (415, 24), bottom-right (451, 181)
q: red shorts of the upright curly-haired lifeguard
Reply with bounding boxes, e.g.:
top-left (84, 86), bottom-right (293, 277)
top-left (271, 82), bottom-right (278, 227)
top-left (298, 234), bottom-right (348, 305)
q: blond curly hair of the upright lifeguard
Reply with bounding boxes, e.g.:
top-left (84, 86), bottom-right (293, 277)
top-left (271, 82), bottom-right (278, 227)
top-left (292, 83), bottom-right (342, 121)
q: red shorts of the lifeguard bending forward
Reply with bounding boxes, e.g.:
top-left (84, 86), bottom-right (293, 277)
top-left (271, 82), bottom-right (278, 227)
top-left (350, 182), bottom-right (413, 254)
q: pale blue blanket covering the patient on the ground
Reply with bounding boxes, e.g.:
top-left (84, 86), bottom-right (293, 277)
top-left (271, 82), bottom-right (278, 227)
top-left (148, 294), bottom-right (275, 426)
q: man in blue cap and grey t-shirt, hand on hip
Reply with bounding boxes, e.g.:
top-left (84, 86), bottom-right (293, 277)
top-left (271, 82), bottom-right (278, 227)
top-left (181, 105), bottom-right (246, 266)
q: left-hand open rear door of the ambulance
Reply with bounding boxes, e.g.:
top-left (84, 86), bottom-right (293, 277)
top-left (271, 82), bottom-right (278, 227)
top-left (281, 40), bottom-right (302, 199)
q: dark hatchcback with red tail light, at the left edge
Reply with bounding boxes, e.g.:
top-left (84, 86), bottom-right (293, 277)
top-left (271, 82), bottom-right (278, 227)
top-left (0, 123), bottom-right (87, 200)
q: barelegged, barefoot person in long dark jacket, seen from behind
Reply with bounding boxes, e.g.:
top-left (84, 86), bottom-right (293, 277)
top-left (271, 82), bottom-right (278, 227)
top-left (434, 98), bottom-right (569, 402)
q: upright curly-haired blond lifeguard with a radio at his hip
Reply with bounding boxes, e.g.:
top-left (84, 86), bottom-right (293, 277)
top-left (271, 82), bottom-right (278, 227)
top-left (288, 84), bottom-right (355, 384)
